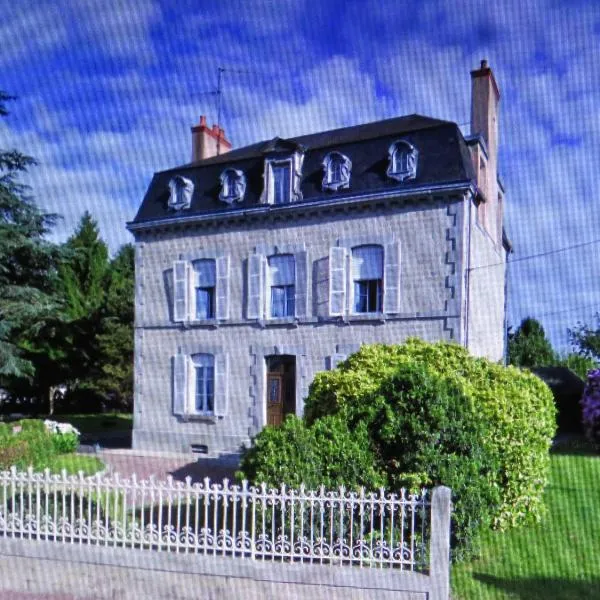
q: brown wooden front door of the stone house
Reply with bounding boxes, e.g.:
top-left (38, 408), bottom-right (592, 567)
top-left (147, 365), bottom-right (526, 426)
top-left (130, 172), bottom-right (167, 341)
top-left (266, 356), bottom-right (296, 427)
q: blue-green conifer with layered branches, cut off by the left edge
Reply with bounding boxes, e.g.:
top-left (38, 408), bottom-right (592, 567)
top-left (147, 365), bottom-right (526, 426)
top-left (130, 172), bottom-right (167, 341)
top-left (0, 91), bottom-right (61, 384)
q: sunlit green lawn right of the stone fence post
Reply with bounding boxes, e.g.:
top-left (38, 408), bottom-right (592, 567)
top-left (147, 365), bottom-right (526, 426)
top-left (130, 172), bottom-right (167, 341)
top-left (452, 444), bottom-right (600, 600)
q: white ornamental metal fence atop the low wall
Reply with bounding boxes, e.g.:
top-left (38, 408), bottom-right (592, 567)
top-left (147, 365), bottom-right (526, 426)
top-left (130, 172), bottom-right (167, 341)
top-left (0, 467), bottom-right (440, 571)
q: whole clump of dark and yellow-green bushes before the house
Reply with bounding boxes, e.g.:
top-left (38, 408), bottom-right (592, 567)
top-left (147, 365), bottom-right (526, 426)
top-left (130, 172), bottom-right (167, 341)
top-left (242, 339), bottom-right (556, 557)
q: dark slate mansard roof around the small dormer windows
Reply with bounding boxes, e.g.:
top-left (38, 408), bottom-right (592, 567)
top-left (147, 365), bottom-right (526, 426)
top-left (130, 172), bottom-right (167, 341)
top-left (128, 115), bottom-right (475, 230)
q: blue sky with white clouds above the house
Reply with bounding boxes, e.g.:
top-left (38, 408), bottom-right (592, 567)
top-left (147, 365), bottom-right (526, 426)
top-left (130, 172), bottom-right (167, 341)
top-left (0, 0), bottom-right (600, 349)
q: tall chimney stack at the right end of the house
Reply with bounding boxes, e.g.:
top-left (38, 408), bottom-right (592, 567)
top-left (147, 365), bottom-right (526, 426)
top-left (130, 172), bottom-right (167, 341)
top-left (471, 60), bottom-right (502, 239)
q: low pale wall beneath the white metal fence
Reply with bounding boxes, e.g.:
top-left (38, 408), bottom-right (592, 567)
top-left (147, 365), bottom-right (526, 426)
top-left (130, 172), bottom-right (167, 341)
top-left (0, 538), bottom-right (440, 600)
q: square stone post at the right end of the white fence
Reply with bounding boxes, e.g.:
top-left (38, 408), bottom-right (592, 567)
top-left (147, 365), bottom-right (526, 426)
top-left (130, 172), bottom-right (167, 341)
top-left (429, 486), bottom-right (451, 600)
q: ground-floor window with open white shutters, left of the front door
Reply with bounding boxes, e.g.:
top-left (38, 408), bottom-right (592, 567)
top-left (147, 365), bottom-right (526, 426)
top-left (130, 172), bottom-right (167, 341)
top-left (172, 351), bottom-right (229, 418)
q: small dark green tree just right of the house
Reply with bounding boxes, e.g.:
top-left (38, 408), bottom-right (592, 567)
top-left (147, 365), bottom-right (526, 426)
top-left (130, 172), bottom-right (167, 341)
top-left (508, 317), bottom-right (558, 369)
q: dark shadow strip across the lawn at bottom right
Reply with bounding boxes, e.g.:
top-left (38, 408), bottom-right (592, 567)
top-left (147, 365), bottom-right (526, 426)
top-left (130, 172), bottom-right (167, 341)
top-left (473, 573), bottom-right (600, 600)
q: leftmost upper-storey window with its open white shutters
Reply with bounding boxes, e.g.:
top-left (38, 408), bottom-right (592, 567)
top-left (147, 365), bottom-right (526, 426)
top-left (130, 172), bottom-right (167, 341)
top-left (172, 251), bottom-right (229, 323)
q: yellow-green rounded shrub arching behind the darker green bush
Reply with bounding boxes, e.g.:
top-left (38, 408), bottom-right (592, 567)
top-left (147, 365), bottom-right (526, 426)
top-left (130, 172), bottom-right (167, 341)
top-left (305, 338), bottom-right (556, 528)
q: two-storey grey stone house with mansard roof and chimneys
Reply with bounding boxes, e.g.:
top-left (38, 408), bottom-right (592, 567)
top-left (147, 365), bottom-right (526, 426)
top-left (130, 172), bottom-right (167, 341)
top-left (128, 61), bottom-right (510, 455)
